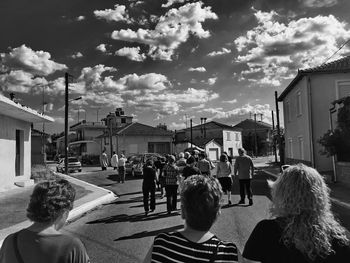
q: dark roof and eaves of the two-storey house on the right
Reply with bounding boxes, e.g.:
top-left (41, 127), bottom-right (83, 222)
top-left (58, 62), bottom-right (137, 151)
top-left (278, 56), bottom-right (350, 101)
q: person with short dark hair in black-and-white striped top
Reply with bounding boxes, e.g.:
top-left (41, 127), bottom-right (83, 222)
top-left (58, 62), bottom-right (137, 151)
top-left (144, 175), bottom-right (242, 263)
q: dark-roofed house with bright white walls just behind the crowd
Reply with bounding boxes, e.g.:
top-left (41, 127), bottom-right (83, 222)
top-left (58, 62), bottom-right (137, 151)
top-left (175, 121), bottom-right (242, 160)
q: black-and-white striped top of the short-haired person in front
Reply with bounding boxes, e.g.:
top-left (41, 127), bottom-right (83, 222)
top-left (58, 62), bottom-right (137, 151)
top-left (151, 232), bottom-right (238, 263)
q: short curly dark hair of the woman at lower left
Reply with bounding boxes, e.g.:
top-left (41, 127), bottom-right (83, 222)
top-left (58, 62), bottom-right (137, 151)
top-left (27, 179), bottom-right (75, 223)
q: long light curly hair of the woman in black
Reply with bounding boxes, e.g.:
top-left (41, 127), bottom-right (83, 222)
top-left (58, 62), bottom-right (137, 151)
top-left (270, 164), bottom-right (349, 261)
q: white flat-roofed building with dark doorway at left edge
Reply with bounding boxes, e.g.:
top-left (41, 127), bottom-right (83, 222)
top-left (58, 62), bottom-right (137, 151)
top-left (0, 95), bottom-right (54, 190)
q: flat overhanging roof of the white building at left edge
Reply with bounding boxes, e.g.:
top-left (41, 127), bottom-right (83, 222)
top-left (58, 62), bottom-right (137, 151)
top-left (0, 94), bottom-right (54, 123)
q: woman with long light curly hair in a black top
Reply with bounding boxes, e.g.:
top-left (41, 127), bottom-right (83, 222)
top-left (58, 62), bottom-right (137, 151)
top-left (243, 164), bottom-right (350, 263)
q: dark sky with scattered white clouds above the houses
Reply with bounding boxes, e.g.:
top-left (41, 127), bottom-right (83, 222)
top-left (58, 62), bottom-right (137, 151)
top-left (0, 0), bottom-right (350, 133)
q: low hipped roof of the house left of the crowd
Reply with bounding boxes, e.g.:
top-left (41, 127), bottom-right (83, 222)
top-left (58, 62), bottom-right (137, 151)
top-left (97, 122), bottom-right (173, 138)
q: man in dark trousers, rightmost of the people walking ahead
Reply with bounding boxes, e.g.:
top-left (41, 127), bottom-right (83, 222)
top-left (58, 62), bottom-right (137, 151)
top-left (233, 148), bottom-right (254, 205)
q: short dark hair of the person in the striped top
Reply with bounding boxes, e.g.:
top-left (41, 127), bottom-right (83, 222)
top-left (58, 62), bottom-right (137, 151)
top-left (181, 175), bottom-right (222, 231)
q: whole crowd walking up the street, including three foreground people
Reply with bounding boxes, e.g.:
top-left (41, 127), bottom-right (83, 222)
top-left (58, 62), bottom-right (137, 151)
top-left (0, 149), bottom-right (350, 263)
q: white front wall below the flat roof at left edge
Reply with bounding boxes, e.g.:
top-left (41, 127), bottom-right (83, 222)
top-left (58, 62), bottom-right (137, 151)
top-left (0, 115), bottom-right (31, 190)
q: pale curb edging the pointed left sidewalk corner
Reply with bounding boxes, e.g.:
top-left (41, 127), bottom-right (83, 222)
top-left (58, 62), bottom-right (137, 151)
top-left (0, 174), bottom-right (118, 247)
